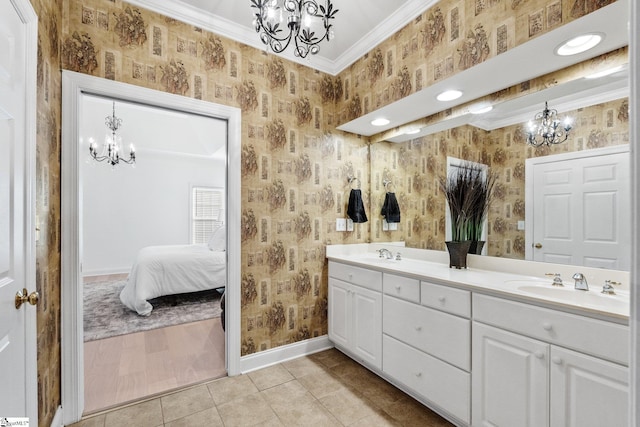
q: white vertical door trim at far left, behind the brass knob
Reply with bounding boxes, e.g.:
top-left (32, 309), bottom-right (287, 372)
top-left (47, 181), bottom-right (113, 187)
top-left (10, 0), bottom-right (38, 425)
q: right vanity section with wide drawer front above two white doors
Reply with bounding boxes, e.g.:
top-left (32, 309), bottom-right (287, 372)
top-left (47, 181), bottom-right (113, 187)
top-left (472, 294), bottom-right (629, 427)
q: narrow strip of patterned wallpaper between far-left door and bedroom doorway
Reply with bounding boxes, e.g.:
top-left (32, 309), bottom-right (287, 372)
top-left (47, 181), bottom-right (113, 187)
top-left (31, 0), bottom-right (62, 426)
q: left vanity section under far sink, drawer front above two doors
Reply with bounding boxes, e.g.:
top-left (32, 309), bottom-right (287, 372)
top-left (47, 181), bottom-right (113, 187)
top-left (328, 262), bottom-right (382, 369)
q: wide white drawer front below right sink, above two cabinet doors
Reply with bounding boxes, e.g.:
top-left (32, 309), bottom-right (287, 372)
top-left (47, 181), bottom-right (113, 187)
top-left (473, 293), bottom-right (629, 365)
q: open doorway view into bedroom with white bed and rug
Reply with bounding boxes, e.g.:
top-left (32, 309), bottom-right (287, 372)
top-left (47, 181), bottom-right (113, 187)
top-left (78, 94), bottom-right (227, 415)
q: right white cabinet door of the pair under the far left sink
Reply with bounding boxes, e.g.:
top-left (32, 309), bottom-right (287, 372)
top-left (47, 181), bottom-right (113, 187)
top-left (351, 286), bottom-right (382, 369)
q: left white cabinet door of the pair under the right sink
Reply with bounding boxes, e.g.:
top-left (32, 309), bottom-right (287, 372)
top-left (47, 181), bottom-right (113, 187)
top-left (471, 322), bottom-right (549, 427)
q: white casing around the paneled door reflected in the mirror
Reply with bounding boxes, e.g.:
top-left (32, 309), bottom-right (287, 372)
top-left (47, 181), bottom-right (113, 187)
top-left (524, 144), bottom-right (633, 262)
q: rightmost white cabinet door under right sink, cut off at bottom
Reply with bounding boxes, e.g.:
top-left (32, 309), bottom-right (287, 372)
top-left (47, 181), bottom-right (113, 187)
top-left (550, 346), bottom-right (629, 427)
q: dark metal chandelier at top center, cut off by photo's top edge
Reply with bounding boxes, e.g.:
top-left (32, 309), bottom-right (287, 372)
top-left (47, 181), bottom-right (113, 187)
top-left (251, 0), bottom-right (338, 58)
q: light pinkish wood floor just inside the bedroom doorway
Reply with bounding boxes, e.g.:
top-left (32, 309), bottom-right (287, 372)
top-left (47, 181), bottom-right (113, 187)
top-left (84, 318), bottom-right (227, 415)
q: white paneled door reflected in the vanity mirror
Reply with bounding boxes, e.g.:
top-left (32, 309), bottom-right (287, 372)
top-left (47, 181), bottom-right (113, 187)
top-left (527, 149), bottom-right (631, 270)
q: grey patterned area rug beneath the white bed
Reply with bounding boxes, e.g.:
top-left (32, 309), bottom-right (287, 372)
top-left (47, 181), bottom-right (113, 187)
top-left (84, 280), bottom-right (222, 342)
